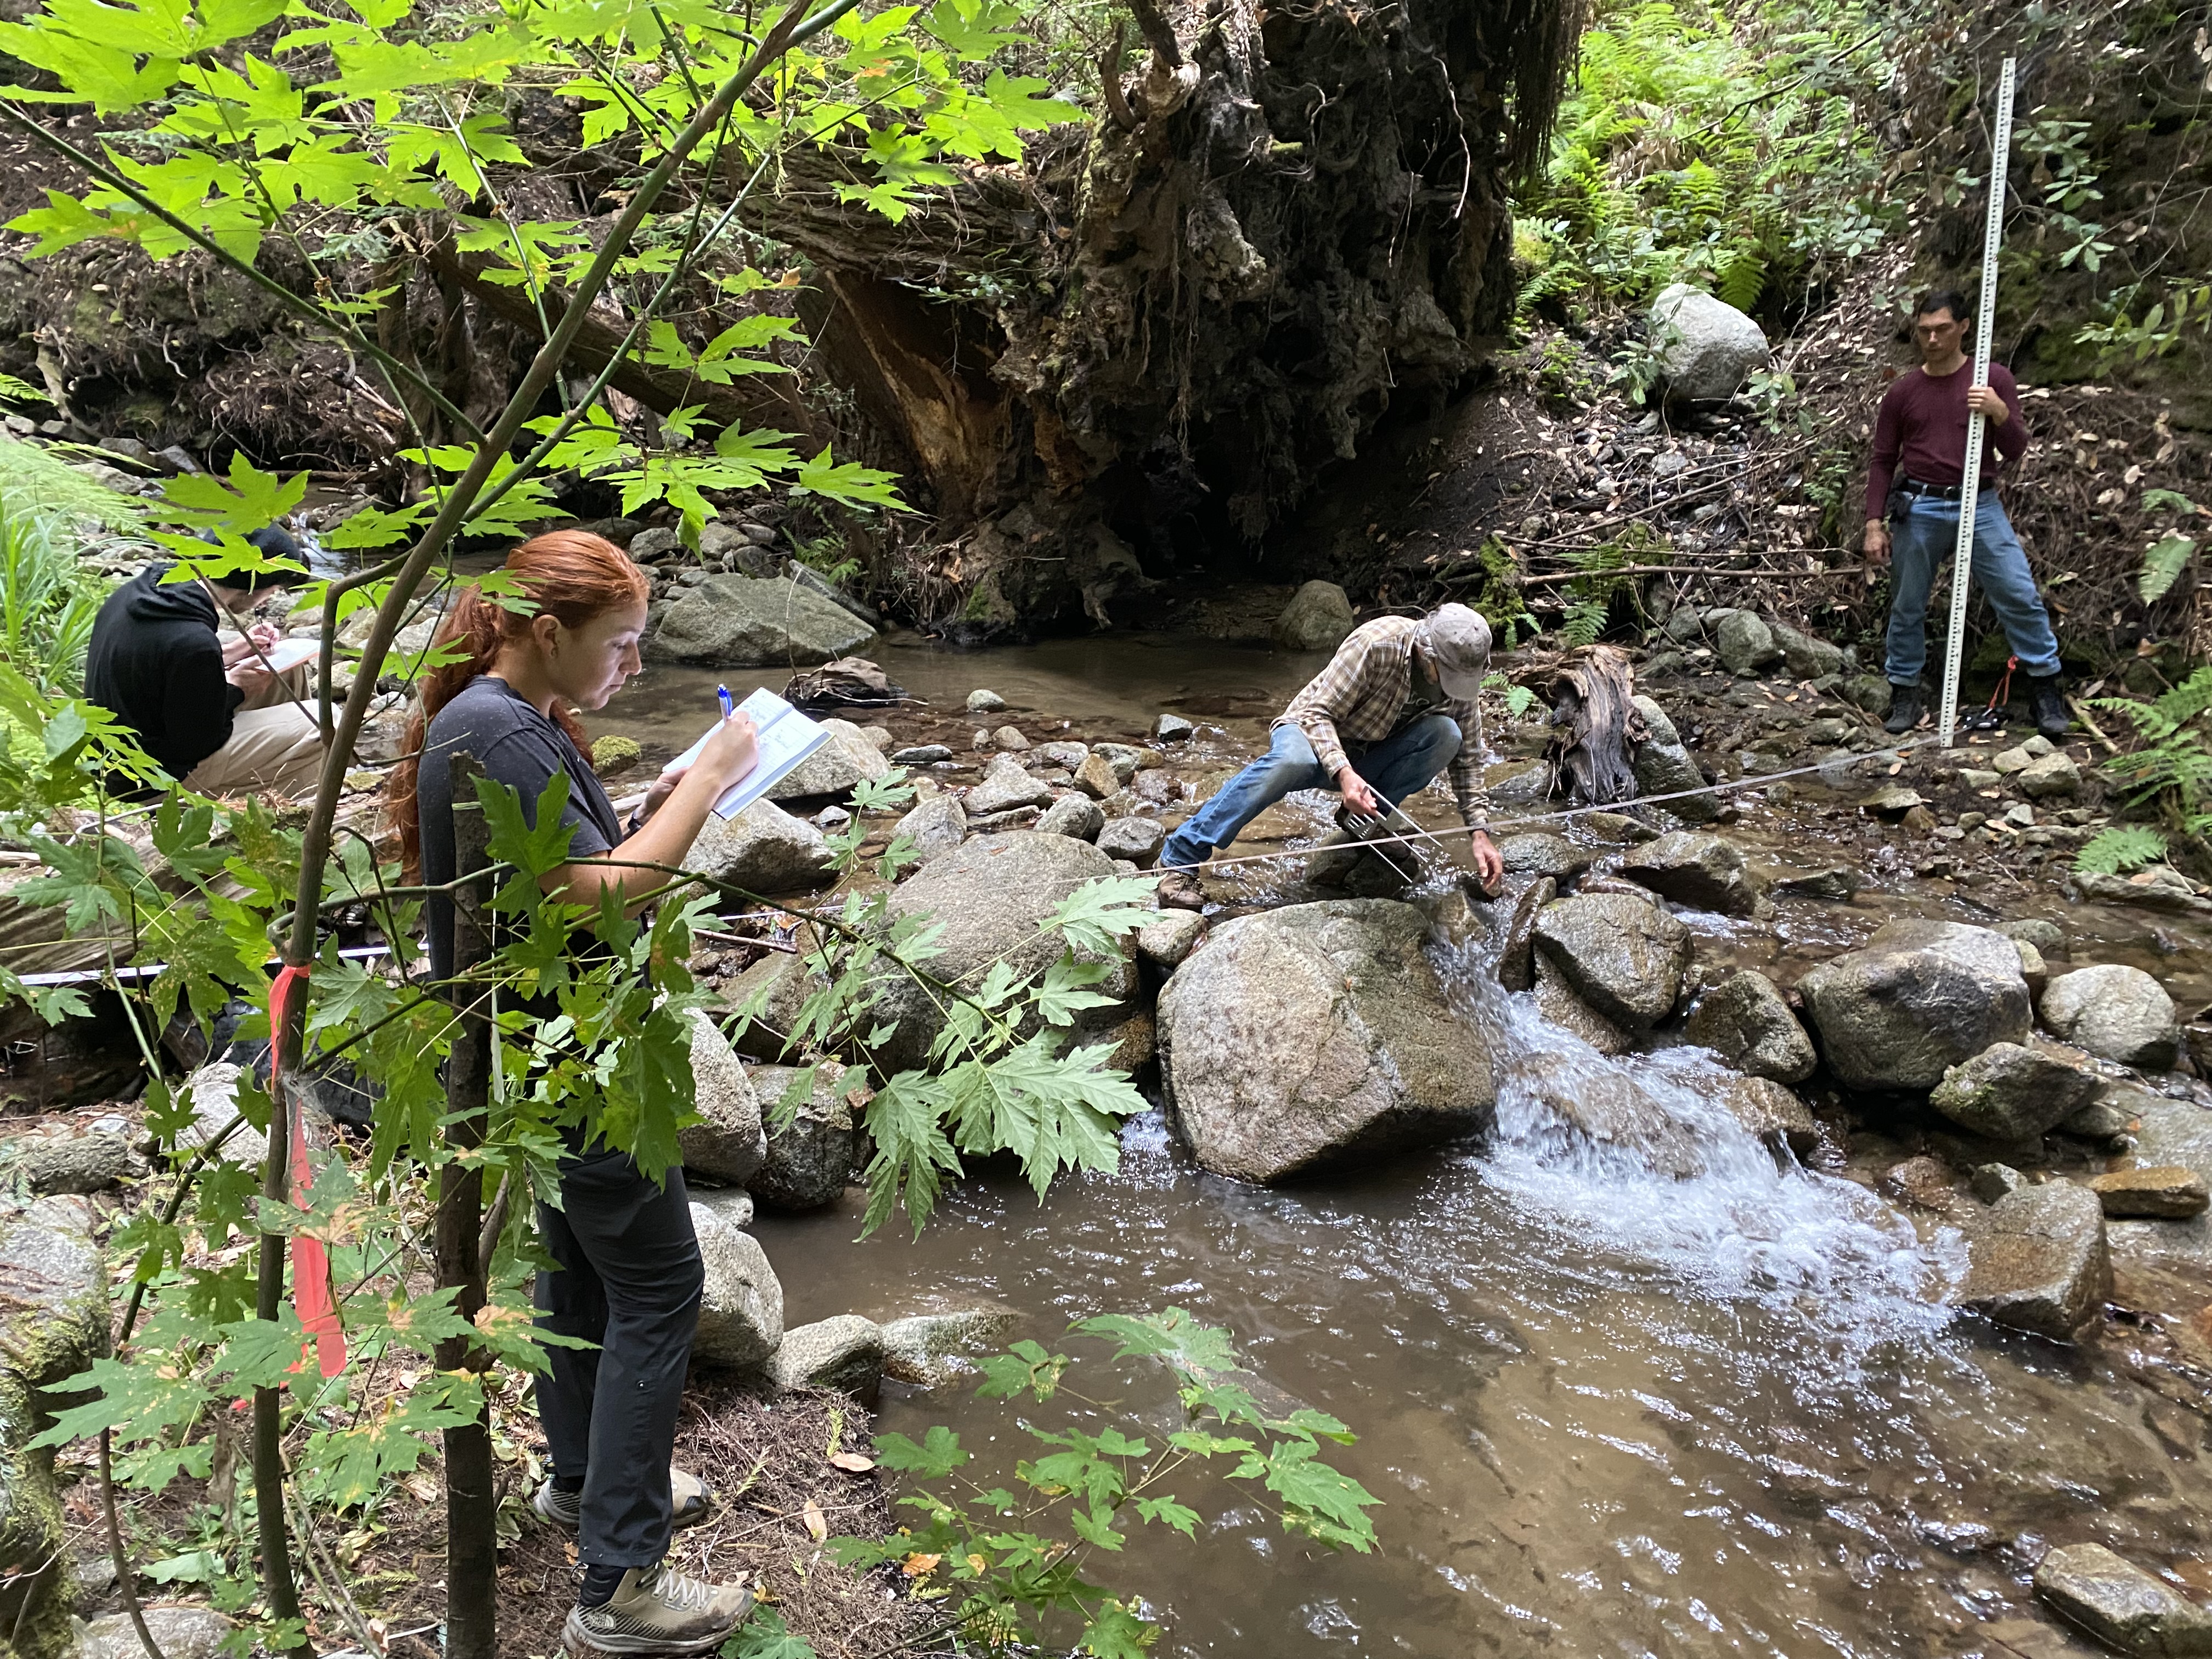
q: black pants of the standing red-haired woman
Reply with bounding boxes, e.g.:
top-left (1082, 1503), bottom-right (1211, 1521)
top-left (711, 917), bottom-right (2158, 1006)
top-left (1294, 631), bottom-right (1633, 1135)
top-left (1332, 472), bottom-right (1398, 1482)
top-left (538, 1150), bottom-right (706, 1566)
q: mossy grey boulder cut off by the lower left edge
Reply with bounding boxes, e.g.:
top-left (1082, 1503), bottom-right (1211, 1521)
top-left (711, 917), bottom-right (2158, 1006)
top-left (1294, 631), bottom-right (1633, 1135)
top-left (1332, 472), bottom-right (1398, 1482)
top-left (0, 1194), bottom-right (109, 1659)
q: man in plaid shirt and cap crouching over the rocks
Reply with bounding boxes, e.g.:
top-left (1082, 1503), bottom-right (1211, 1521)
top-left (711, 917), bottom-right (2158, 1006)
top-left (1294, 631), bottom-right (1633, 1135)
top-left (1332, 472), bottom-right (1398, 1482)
top-left (1159, 604), bottom-right (1504, 909)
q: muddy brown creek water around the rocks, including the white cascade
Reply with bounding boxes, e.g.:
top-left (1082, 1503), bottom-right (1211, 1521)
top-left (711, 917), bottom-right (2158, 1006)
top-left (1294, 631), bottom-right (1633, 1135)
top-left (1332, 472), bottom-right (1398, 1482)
top-left (597, 639), bottom-right (2212, 1659)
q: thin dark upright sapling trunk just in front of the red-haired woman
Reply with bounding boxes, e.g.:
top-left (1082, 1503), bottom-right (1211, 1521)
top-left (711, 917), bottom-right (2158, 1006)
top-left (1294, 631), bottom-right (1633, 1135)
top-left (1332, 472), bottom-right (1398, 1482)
top-left (433, 754), bottom-right (500, 1659)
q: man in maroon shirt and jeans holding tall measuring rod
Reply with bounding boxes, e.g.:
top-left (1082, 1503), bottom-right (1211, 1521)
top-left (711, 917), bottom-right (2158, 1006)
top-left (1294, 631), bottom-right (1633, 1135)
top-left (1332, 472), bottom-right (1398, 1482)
top-left (1865, 287), bottom-right (2068, 739)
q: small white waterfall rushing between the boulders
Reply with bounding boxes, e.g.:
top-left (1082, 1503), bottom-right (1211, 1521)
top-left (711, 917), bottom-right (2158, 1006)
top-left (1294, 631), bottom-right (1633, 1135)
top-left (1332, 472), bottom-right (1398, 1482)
top-left (1438, 949), bottom-right (1966, 1369)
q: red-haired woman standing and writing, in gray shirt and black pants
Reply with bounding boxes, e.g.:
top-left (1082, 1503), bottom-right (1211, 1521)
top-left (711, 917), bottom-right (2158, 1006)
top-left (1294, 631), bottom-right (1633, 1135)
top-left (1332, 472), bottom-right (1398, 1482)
top-left (390, 531), bottom-right (757, 1655)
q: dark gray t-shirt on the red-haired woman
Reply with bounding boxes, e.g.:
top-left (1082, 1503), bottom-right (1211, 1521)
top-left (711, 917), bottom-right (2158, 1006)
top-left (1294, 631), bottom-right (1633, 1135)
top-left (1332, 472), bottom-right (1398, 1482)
top-left (416, 675), bottom-right (622, 980)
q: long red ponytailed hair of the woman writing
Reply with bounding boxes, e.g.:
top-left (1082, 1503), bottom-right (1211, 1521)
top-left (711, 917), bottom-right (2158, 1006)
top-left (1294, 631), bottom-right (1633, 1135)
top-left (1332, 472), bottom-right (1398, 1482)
top-left (385, 531), bottom-right (650, 881)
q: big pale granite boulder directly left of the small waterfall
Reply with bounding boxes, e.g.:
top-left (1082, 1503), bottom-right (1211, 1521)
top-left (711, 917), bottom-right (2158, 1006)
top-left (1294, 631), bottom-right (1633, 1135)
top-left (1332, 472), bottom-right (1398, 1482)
top-left (1159, 898), bottom-right (1498, 1181)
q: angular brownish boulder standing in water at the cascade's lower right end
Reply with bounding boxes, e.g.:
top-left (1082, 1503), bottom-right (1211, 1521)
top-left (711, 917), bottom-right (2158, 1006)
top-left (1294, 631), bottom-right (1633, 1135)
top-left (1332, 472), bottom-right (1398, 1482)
top-left (1953, 1181), bottom-right (2113, 1342)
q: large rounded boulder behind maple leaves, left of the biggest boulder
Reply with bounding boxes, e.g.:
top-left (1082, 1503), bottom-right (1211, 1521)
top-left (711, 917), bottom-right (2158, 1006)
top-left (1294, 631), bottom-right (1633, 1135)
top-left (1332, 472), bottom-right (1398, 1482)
top-left (872, 830), bottom-right (1137, 1075)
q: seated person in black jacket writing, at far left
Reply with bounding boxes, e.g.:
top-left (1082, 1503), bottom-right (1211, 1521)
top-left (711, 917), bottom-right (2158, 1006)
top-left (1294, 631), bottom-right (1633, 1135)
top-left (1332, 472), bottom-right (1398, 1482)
top-left (84, 524), bottom-right (323, 794)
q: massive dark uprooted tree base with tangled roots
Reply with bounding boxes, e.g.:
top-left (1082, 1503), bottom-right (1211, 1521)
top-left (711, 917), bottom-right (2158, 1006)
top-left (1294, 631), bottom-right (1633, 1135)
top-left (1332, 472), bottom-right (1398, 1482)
top-left (746, 0), bottom-right (1582, 633)
